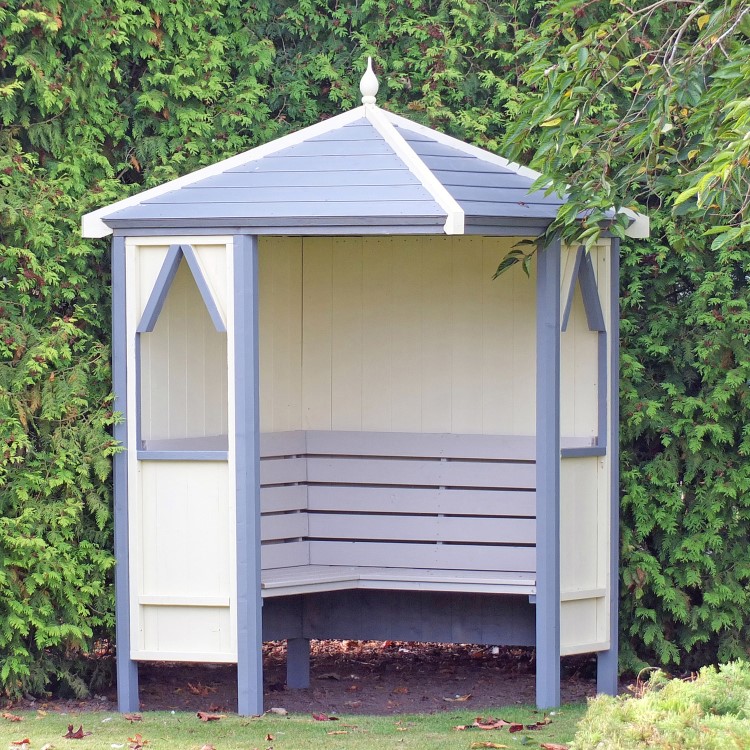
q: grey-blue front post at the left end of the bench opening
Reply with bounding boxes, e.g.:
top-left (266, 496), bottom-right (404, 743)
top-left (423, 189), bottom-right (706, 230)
top-left (234, 235), bottom-right (263, 716)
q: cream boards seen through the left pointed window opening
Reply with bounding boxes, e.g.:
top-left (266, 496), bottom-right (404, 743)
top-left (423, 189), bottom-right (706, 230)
top-left (140, 260), bottom-right (228, 440)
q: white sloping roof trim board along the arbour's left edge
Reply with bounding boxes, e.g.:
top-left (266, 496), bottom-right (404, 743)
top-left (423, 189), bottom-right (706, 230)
top-left (81, 107), bottom-right (365, 237)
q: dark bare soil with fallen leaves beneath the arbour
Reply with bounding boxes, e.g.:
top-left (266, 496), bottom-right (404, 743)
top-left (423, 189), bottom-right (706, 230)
top-left (2, 641), bottom-right (596, 715)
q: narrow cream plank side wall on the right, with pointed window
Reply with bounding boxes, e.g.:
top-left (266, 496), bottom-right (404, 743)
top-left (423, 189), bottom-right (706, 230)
top-left (560, 240), bottom-right (617, 654)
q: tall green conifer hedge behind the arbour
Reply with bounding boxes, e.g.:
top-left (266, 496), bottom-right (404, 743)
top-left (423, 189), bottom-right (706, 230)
top-left (0, 0), bottom-right (750, 696)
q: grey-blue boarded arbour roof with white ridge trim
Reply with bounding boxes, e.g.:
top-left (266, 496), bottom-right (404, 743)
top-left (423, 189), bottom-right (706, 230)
top-left (83, 104), bottom-right (563, 237)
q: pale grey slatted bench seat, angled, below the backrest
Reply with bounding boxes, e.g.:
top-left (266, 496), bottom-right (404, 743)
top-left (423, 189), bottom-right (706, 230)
top-left (261, 565), bottom-right (536, 598)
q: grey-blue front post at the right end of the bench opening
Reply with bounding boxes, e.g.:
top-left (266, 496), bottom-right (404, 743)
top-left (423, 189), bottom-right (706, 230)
top-left (536, 239), bottom-right (561, 708)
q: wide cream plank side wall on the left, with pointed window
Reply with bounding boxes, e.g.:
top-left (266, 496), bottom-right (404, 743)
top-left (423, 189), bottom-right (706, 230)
top-left (126, 237), bottom-right (237, 662)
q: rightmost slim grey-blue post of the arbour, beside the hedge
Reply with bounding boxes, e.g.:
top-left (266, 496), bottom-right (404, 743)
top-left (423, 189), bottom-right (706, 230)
top-left (596, 237), bottom-right (620, 695)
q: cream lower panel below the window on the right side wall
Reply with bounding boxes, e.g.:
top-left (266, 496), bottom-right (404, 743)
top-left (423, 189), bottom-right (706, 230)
top-left (560, 456), bottom-right (603, 593)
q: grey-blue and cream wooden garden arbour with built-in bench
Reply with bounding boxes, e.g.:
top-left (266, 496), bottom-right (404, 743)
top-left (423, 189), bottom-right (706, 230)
top-left (83, 63), bottom-right (648, 714)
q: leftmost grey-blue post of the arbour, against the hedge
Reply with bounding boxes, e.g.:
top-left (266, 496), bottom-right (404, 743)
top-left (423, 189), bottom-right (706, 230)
top-left (112, 237), bottom-right (140, 713)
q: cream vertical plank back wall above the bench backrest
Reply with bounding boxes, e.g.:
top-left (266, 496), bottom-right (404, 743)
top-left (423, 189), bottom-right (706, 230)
top-left (260, 237), bottom-right (536, 435)
